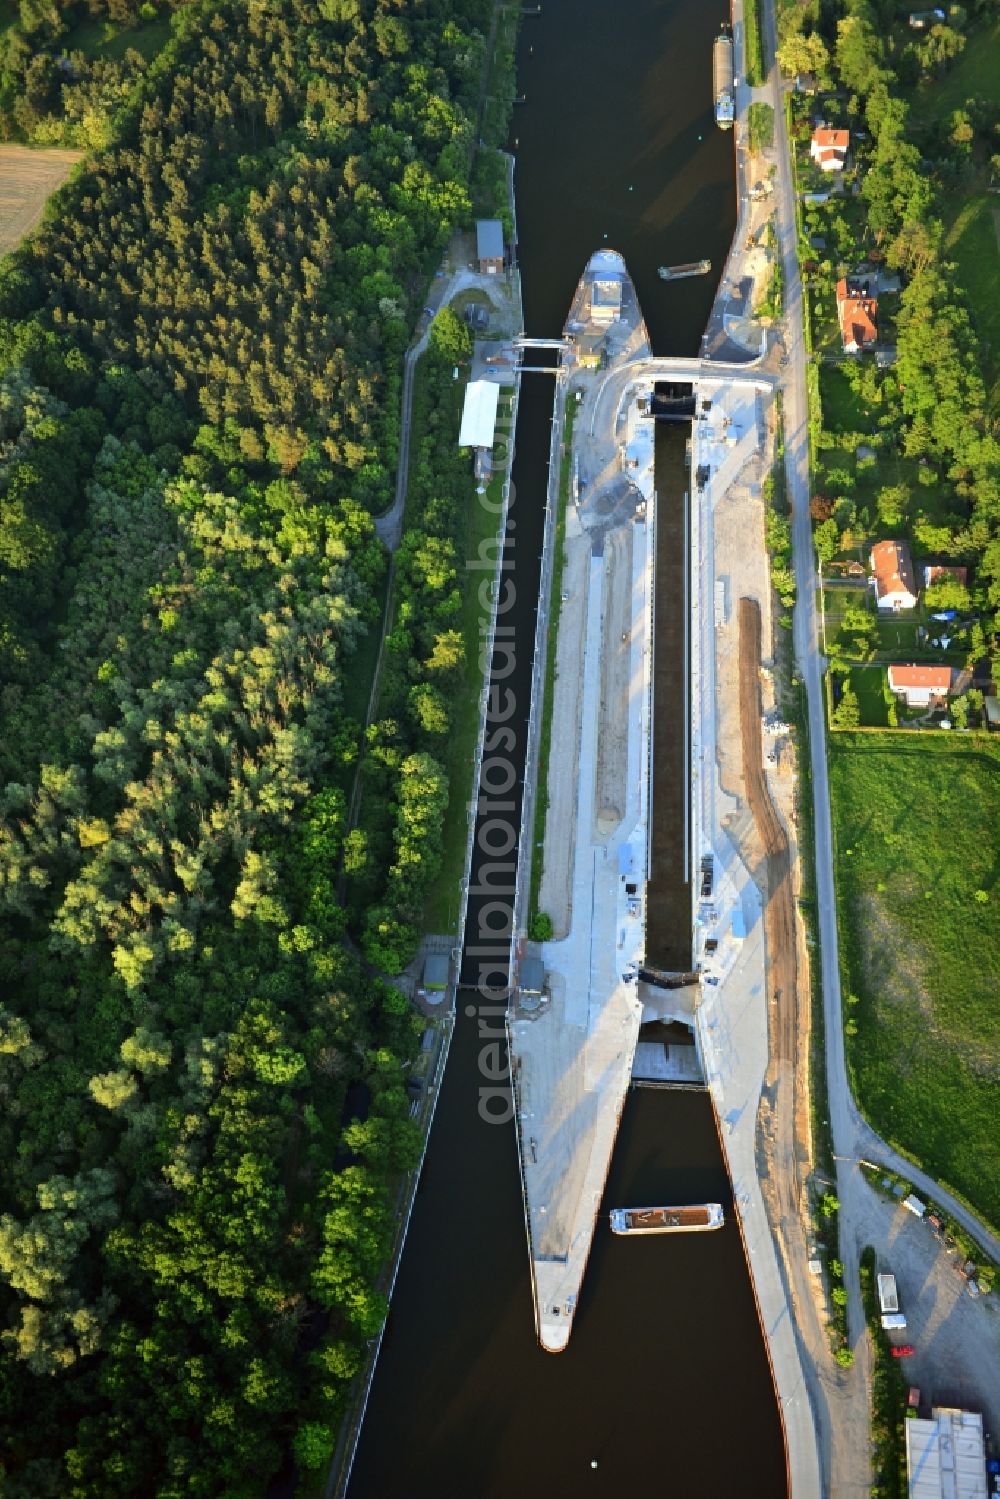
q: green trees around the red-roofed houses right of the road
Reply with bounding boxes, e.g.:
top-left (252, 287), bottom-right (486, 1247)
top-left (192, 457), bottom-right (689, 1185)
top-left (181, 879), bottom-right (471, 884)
top-left (778, 0), bottom-right (1000, 617)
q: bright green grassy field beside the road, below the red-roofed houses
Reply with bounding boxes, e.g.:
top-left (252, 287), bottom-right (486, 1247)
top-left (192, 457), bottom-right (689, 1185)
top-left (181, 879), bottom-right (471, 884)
top-left (829, 732), bottom-right (1000, 1228)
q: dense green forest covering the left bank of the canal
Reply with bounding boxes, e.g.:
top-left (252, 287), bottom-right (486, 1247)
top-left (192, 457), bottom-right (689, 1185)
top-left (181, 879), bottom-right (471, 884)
top-left (0, 0), bottom-right (490, 1499)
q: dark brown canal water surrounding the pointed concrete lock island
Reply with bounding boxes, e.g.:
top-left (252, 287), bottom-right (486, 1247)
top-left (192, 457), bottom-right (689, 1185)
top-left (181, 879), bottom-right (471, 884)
top-left (349, 0), bottom-right (786, 1499)
